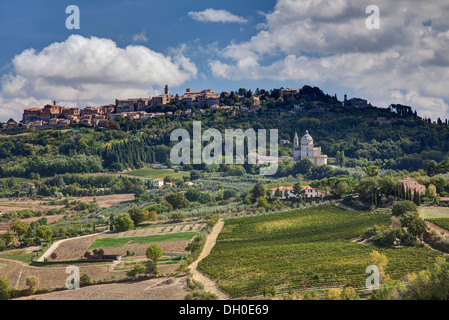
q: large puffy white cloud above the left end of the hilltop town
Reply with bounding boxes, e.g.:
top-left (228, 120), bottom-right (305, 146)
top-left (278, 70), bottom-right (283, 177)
top-left (0, 35), bottom-right (198, 118)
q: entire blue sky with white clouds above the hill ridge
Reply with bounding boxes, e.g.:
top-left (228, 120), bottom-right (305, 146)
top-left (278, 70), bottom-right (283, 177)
top-left (0, 0), bottom-right (449, 121)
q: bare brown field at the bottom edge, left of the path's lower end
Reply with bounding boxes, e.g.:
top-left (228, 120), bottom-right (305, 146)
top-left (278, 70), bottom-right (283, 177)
top-left (16, 277), bottom-right (189, 300)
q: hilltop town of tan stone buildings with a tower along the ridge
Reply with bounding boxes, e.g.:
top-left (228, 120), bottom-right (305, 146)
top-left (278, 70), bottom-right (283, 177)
top-left (14, 85), bottom-right (369, 129)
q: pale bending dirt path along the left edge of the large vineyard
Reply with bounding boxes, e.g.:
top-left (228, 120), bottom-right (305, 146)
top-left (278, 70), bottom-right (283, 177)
top-left (189, 219), bottom-right (230, 300)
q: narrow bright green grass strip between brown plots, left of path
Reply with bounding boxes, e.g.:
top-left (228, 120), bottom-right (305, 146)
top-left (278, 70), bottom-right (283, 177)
top-left (89, 232), bottom-right (197, 249)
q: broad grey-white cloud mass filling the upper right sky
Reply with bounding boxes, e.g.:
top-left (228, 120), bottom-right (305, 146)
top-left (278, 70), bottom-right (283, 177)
top-left (209, 0), bottom-right (449, 118)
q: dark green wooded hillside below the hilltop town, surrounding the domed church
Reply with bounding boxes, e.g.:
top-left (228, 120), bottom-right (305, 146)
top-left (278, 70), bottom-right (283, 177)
top-left (0, 87), bottom-right (449, 178)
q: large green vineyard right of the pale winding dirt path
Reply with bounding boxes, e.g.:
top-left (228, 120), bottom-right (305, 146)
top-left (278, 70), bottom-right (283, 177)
top-left (199, 205), bottom-right (438, 297)
